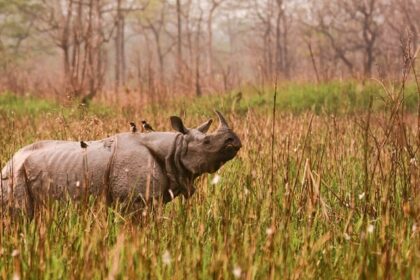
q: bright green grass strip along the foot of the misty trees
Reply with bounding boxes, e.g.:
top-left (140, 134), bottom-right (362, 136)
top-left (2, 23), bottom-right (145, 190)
top-left (0, 81), bottom-right (419, 118)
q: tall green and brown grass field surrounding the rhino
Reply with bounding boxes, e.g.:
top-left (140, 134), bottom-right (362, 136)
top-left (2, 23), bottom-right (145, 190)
top-left (0, 82), bottom-right (420, 279)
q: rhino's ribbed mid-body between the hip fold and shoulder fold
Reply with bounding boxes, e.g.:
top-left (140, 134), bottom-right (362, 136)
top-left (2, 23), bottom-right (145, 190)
top-left (25, 139), bottom-right (112, 199)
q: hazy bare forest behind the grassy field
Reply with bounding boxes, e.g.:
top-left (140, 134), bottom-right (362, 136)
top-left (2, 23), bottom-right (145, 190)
top-left (0, 0), bottom-right (420, 103)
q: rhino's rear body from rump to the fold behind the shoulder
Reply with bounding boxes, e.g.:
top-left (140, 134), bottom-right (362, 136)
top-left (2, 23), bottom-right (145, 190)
top-left (2, 139), bottom-right (113, 203)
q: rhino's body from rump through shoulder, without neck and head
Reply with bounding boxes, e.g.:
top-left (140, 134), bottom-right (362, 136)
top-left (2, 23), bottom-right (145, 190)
top-left (2, 133), bottom-right (168, 209)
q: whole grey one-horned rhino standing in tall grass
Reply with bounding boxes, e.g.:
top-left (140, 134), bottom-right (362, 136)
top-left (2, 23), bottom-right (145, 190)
top-left (0, 111), bottom-right (241, 216)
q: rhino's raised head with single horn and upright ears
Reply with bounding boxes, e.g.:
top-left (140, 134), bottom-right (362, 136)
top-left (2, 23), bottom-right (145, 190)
top-left (171, 111), bottom-right (242, 177)
